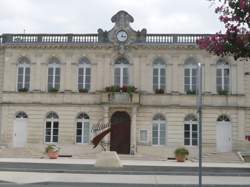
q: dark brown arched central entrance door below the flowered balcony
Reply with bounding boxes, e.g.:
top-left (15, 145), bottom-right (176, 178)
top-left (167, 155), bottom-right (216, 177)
top-left (110, 112), bottom-right (130, 154)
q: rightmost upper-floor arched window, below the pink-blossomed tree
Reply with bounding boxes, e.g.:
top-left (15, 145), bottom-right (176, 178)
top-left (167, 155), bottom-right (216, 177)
top-left (216, 60), bottom-right (230, 93)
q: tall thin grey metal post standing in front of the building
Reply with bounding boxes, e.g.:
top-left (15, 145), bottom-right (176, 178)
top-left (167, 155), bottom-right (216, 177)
top-left (196, 63), bottom-right (202, 187)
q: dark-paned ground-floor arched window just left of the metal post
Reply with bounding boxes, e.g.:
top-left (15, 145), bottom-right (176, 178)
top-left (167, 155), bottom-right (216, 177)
top-left (184, 114), bottom-right (198, 145)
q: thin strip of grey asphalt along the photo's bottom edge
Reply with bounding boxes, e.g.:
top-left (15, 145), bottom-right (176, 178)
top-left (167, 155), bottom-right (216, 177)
top-left (0, 183), bottom-right (249, 187)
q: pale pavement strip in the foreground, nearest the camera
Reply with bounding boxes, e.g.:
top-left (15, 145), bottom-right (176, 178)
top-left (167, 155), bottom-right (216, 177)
top-left (0, 172), bottom-right (250, 186)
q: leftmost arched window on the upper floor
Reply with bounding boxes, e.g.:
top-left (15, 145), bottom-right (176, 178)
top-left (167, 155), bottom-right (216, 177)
top-left (17, 57), bottom-right (30, 91)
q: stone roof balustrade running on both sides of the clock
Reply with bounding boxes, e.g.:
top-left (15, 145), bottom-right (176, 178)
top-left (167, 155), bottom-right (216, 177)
top-left (0, 34), bottom-right (209, 45)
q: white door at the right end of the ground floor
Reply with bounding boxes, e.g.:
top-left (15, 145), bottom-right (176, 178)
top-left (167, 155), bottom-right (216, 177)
top-left (216, 121), bottom-right (232, 152)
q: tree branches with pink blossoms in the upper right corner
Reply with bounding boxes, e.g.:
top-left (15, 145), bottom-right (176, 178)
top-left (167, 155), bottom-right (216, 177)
top-left (197, 0), bottom-right (250, 60)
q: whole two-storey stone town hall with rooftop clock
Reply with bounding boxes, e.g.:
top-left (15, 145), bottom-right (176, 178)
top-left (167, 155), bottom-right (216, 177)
top-left (0, 11), bottom-right (250, 157)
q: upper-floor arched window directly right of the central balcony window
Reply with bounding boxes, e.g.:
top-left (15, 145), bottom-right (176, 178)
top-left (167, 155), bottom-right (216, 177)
top-left (153, 58), bottom-right (166, 90)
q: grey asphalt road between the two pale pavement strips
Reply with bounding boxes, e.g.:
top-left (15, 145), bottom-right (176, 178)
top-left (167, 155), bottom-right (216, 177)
top-left (0, 162), bottom-right (250, 177)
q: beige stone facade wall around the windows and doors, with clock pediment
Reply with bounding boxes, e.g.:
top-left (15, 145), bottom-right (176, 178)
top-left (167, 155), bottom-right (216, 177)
top-left (0, 12), bottom-right (250, 157)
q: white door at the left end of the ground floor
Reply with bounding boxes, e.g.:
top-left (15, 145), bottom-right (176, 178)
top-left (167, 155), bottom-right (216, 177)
top-left (13, 118), bottom-right (27, 147)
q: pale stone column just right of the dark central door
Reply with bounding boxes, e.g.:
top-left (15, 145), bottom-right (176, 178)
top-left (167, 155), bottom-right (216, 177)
top-left (130, 106), bottom-right (137, 155)
